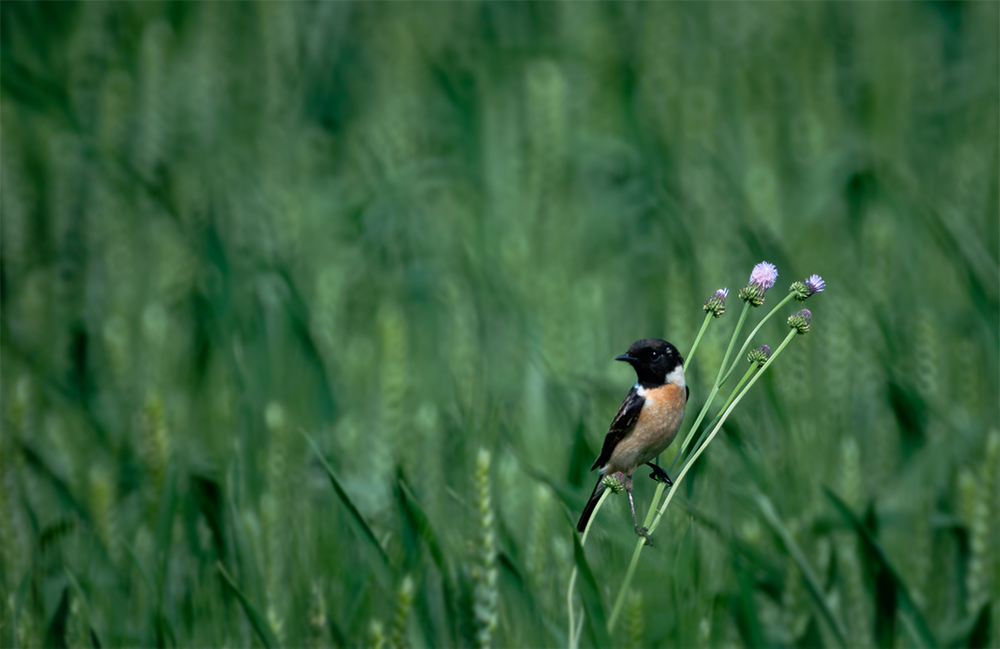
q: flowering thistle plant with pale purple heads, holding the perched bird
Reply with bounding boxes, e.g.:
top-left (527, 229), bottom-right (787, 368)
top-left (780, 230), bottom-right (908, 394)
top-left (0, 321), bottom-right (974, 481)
top-left (567, 261), bottom-right (826, 636)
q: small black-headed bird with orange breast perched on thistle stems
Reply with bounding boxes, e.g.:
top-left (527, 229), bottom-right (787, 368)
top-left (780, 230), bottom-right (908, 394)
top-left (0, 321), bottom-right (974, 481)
top-left (576, 338), bottom-right (690, 544)
